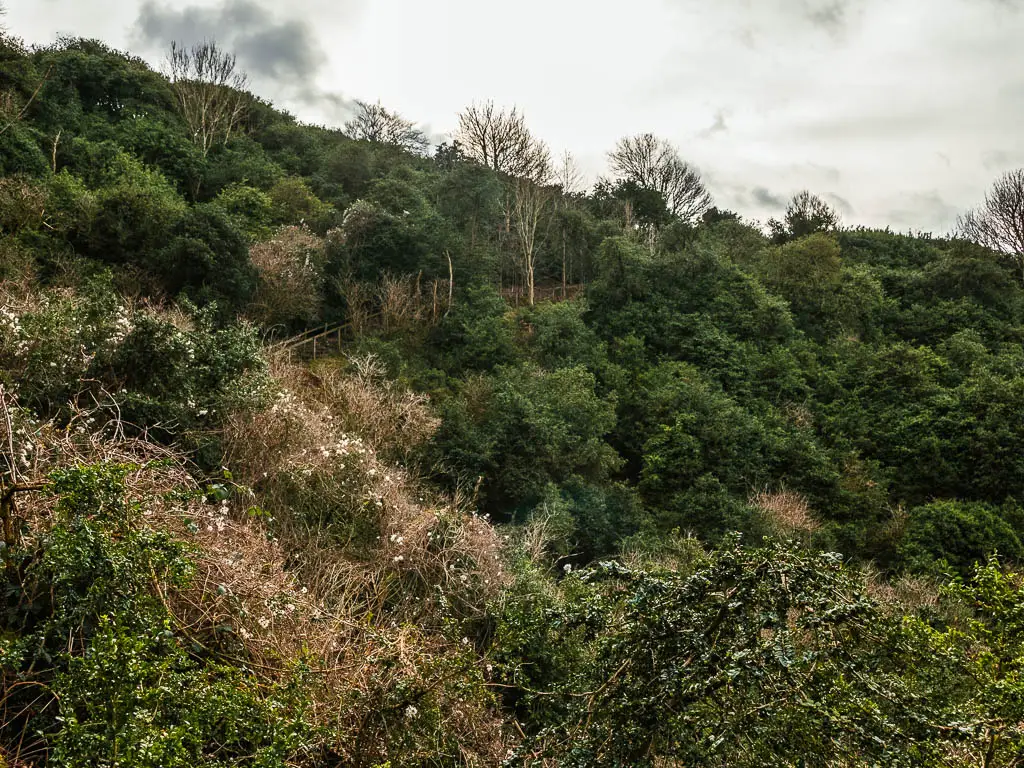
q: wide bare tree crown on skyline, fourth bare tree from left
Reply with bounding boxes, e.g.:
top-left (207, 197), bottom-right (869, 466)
top-left (608, 133), bottom-right (712, 222)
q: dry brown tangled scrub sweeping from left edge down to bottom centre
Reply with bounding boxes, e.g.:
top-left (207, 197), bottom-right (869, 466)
top-left (0, 362), bottom-right (509, 766)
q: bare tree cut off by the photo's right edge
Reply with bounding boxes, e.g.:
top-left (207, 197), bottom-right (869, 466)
top-left (956, 168), bottom-right (1024, 278)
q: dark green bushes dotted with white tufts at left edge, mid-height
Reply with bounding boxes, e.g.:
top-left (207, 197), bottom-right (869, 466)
top-left (0, 279), bottom-right (266, 450)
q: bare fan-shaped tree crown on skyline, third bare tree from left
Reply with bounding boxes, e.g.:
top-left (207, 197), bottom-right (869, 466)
top-left (455, 101), bottom-right (551, 183)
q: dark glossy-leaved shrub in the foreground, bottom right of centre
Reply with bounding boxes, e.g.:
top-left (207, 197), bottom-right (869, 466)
top-left (498, 543), bottom-right (938, 766)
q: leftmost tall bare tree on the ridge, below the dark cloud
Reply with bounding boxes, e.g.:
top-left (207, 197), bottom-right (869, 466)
top-left (167, 40), bottom-right (250, 157)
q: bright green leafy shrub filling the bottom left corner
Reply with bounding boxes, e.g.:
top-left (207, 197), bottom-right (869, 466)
top-left (0, 465), bottom-right (304, 768)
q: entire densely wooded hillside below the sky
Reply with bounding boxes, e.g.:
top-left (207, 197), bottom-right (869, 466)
top-left (0, 27), bottom-right (1024, 768)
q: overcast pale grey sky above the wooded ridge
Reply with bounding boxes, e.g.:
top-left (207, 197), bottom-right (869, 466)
top-left (6, 0), bottom-right (1024, 233)
